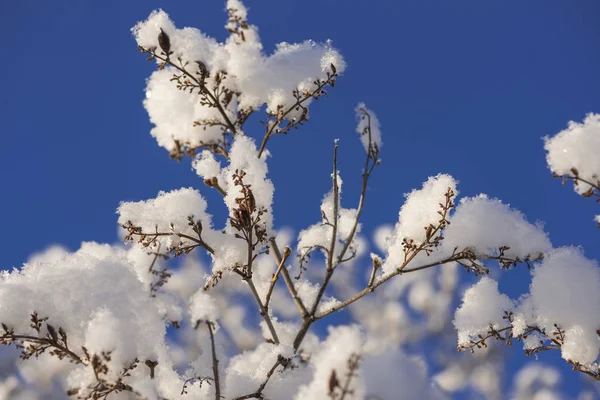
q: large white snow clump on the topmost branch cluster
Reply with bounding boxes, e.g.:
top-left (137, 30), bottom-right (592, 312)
top-left (132, 6), bottom-right (346, 151)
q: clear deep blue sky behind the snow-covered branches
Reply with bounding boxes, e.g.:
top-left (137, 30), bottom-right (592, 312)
top-left (0, 0), bottom-right (600, 396)
